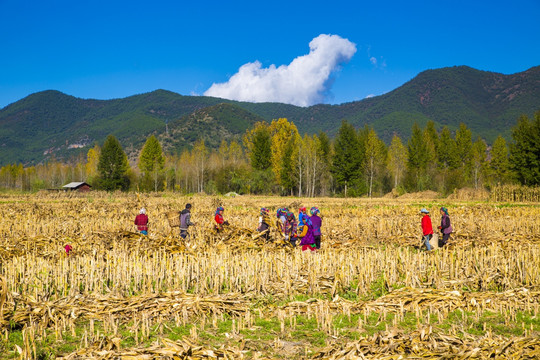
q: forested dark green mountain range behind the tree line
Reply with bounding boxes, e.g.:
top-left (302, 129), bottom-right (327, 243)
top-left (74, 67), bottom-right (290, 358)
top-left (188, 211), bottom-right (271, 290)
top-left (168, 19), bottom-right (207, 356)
top-left (0, 66), bottom-right (540, 166)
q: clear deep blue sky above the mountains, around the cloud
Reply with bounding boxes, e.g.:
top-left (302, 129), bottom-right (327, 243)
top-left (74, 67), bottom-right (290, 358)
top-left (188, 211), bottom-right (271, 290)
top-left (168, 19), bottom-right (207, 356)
top-left (0, 0), bottom-right (540, 108)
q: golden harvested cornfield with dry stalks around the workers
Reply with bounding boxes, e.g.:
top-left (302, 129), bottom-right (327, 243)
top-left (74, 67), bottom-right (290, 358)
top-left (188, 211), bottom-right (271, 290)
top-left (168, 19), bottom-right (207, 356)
top-left (0, 192), bottom-right (540, 359)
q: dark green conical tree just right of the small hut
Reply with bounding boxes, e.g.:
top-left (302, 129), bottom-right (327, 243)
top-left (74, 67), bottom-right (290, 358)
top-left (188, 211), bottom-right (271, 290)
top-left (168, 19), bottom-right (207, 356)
top-left (98, 135), bottom-right (129, 191)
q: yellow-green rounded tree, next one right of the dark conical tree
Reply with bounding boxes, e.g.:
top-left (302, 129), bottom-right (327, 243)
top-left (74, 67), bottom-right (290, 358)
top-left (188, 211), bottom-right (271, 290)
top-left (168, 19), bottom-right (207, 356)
top-left (139, 135), bottom-right (165, 191)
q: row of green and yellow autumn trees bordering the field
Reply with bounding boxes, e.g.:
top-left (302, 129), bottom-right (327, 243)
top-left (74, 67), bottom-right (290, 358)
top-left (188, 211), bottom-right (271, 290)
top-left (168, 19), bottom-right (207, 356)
top-left (0, 112), bottom-right (540, 197)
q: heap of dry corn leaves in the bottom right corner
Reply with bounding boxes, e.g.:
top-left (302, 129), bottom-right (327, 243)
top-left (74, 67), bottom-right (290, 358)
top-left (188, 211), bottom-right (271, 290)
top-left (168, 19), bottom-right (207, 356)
top-left (313, 327), bottom-right (540, 360)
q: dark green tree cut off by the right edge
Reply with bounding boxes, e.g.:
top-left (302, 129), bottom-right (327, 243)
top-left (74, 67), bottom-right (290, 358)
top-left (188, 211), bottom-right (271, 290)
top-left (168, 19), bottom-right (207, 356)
top-left (510, 111), bottom-right (540, 186)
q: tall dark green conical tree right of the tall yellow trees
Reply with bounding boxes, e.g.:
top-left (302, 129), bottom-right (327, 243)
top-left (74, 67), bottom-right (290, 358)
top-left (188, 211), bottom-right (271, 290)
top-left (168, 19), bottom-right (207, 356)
top-left (332, 120), bottom-right (362, 197)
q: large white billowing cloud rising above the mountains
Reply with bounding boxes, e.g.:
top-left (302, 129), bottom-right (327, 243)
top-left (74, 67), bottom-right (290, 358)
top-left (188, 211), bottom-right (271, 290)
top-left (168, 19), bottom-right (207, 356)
top-left (204, 34), bottom-right (356, 106)
